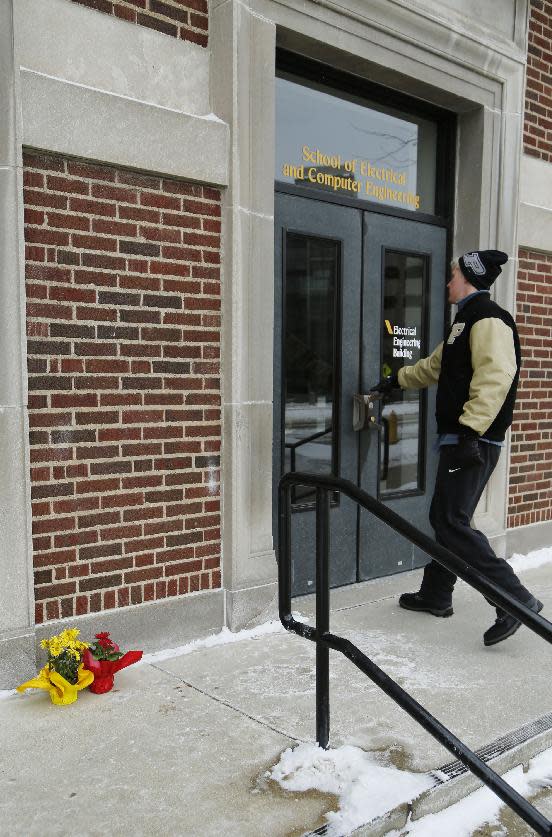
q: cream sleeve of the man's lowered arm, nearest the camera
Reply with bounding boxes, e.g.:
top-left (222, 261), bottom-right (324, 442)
top-left (460, 317), bottom-right (517, 436)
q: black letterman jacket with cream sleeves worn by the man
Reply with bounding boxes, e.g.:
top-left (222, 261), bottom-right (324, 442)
top-left (398, 293), bottom-right (521, 442)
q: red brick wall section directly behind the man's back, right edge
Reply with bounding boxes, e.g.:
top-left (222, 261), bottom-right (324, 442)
top-left (508, 249), bottom-right (552, 527)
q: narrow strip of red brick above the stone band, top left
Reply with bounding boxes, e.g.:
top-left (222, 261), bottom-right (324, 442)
top-left (71, 0), bottom-right (209, 46)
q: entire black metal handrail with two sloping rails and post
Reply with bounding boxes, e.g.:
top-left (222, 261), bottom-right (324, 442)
top-left (278, 472), bottom-right (552, 837)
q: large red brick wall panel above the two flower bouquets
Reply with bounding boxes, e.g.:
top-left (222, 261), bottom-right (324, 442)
top-left (24, 153), bottom-right (220, 622)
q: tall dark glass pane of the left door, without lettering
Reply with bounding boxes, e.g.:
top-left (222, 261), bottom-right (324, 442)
top-left (283, 232), bottom-right (340, 505)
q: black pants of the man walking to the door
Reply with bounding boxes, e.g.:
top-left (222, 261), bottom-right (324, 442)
top-left (421, 442), bottom-right (533, 610)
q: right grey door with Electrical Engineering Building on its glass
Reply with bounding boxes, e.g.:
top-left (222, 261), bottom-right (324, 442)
top-left (358, 213), bottom-right (448, 580)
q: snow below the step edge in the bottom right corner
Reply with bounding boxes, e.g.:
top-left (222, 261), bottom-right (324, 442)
top-left (388, 749), bottom-right (552, 837)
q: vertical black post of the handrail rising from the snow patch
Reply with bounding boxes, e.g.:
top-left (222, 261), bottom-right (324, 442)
top-left (316, 488), bottom-right (330, 750)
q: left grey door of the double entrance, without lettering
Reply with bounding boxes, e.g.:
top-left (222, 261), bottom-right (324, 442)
top-left (273, 194), bottom-right (362, 595)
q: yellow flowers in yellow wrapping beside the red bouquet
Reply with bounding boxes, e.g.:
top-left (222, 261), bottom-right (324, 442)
top-left (17, 628), bottom-right (94, 706)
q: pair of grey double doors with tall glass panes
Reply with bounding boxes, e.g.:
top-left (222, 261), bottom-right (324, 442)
top-left (273, 193), bottom-right (447, 595)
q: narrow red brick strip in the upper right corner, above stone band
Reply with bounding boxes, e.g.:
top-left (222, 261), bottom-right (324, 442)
top-left (523, 0), bottom-right (552, 162)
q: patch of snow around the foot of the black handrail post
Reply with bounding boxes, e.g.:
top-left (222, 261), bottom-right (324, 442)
top-left (266, 744), bottom-right (436, 837)
